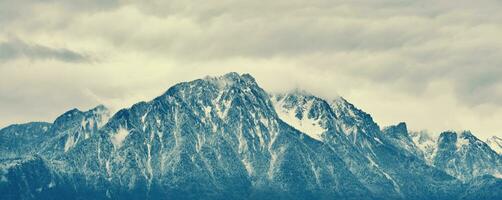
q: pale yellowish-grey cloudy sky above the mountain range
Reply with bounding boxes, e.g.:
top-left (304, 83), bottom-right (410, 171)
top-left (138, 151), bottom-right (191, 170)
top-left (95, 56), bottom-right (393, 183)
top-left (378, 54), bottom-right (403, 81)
top-left (0, 0), bottom-right (502, 139)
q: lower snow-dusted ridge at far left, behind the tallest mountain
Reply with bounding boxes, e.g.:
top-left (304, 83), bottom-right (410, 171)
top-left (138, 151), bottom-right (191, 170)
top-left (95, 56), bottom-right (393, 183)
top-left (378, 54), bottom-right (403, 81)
top-left (0, 106), bottom-right (110, 158)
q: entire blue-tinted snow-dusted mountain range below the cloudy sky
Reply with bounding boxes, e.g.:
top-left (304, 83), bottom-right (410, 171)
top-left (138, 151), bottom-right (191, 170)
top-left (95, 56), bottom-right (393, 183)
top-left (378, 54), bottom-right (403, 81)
top-left (0, 73), bottom-right (502, 200)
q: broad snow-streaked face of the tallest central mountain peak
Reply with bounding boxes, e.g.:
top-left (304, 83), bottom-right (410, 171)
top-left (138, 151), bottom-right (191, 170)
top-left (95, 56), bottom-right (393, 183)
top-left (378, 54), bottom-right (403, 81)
top-left (42, 73), bottom-right (371, 199)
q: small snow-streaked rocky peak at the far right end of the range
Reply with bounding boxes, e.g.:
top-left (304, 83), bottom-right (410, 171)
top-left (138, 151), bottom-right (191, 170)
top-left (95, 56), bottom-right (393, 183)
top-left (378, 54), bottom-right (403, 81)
top-left (433, 132), bottom-right (502, 181)
